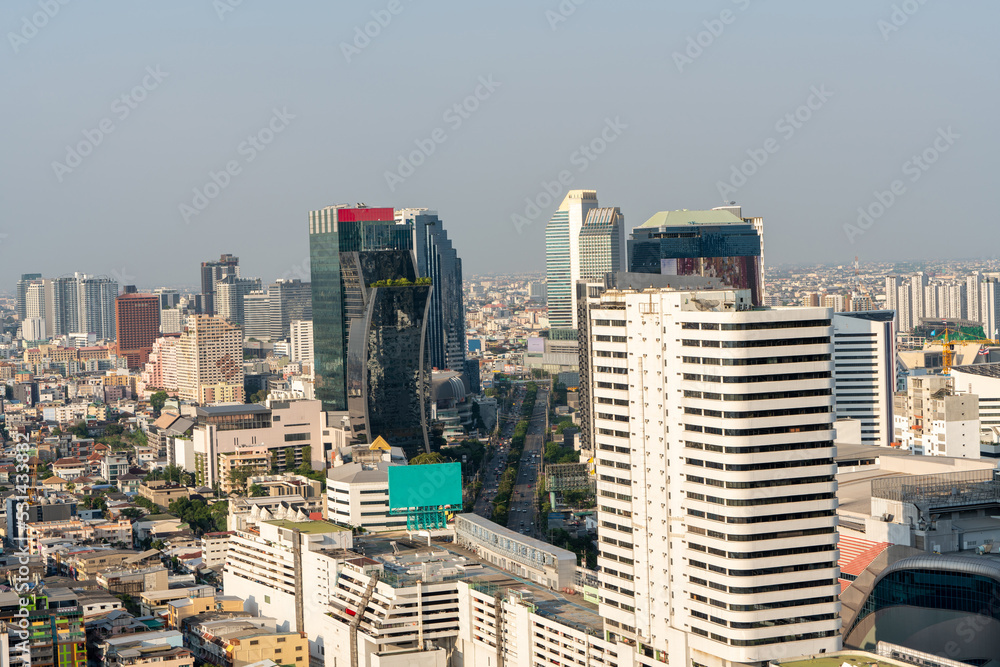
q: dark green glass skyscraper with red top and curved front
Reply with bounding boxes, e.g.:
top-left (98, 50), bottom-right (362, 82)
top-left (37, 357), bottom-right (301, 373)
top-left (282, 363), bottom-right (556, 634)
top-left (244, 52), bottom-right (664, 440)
top-left (309, 206), bottom-right (431, 454)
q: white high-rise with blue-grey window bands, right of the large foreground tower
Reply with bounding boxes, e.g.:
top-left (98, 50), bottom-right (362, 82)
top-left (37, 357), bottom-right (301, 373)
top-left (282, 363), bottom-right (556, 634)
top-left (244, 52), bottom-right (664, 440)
top-left (833, 310), bottom-right (896, 447)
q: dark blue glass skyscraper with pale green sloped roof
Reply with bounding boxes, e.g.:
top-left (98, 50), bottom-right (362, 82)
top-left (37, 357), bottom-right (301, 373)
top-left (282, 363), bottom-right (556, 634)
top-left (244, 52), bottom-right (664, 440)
top-left (628, 209), bottom-right (764, 306)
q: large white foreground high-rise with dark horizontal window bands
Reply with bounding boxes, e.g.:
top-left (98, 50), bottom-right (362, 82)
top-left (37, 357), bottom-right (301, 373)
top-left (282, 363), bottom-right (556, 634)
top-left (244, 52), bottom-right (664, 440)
top-left (587, 289), bottom-right (841, 667)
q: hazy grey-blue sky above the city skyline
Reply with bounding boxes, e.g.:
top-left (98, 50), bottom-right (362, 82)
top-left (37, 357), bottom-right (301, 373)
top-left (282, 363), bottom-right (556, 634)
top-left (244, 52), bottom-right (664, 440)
top-left (0, 0), bottom-right (1000, 291)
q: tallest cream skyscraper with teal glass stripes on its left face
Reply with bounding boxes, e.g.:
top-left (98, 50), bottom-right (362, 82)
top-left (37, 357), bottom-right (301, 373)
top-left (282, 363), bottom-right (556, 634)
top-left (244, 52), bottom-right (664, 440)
top-left (545, 190), bottom-right (597, 336)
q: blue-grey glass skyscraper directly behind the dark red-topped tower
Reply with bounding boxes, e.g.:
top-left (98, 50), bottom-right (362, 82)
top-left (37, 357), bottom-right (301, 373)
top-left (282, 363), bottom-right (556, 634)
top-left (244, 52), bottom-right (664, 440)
top-left (396, 208), bottom-right (466, 373)
